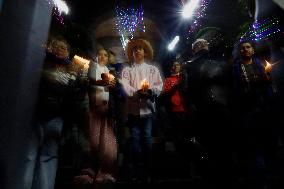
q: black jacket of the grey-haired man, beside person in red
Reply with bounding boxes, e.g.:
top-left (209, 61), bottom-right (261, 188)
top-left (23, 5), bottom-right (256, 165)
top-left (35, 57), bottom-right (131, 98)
top-left (184, 50), bottom-right (231, 111)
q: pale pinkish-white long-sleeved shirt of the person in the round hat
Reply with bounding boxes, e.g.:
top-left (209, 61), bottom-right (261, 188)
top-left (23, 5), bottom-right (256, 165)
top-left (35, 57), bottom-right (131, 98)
top-left (121, 63), bottom-right (163, 115)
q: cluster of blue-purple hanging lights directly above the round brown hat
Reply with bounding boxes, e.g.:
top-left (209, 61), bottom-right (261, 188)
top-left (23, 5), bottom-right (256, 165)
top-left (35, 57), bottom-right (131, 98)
top-left (115, 4), bottom-right (146, 50)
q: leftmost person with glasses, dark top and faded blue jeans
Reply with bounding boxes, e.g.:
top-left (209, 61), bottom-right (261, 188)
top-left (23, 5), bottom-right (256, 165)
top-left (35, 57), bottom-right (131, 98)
top-left (27, 38), bottom-right (77, 189)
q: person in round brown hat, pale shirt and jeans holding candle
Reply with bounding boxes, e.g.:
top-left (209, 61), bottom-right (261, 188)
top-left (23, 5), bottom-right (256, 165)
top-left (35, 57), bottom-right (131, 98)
top-left (122, 39), bottom-right (163, 181)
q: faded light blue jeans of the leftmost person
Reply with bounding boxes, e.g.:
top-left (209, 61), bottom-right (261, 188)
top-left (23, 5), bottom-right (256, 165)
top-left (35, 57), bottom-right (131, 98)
top-left (22, 117), bottom-right (63, 189)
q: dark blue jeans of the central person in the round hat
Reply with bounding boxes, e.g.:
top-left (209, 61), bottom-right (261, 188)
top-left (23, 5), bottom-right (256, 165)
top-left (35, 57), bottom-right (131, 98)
top-left (129, 115), bottom-right (153, 178)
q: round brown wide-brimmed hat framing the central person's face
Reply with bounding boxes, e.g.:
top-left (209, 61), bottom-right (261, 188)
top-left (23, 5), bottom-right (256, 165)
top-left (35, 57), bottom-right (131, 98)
top-left (126, 39), bottom-right (154, 62)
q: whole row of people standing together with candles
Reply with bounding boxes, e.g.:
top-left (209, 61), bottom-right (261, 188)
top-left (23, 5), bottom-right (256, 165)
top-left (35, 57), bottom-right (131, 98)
top-left (28, 29), bottom-right (284, 189)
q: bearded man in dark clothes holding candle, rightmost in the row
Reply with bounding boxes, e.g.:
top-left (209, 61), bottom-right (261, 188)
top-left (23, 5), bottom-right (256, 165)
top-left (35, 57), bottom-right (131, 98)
top-left (233, 40), bottom-right (274, 183)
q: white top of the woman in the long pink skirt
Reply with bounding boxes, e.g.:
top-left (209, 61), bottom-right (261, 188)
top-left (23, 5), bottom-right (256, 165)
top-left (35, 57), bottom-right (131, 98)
top-left (89, 63), bottom-right (109, 105)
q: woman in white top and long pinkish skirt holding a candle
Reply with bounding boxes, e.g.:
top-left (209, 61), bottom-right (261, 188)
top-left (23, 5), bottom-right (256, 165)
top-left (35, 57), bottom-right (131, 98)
top-left (89, 49), bottom-right (117, 183)
